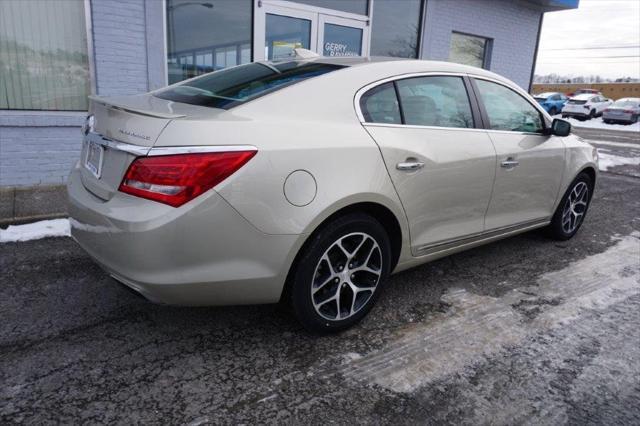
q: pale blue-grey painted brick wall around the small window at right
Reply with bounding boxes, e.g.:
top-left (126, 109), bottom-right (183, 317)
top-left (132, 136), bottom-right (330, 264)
top-left (422, 0), bottom-right (541, 90)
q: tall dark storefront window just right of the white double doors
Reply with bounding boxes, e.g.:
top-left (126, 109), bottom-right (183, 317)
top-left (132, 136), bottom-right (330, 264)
top-left (371, 0), bottom-right (422, 58)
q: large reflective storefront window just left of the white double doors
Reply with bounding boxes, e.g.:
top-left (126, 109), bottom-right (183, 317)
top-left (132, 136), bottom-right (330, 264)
top-left (167, 0), bottom-right (253, 84)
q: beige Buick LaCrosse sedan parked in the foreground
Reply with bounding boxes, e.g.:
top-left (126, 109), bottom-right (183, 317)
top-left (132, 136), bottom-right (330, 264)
top-left (68, 55), bottom-right (597, 332)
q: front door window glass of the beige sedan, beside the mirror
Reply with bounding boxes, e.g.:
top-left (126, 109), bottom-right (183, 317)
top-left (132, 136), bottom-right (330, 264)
top-left (476, 80), bottom-right (544, 133)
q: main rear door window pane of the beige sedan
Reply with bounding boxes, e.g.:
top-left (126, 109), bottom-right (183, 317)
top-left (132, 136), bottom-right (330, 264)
top-left (397, 76), bottom-right (473, 127)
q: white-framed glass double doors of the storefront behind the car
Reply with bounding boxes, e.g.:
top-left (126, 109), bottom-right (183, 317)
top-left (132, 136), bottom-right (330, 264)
top-left (254, 0), bottom-right (369, 61)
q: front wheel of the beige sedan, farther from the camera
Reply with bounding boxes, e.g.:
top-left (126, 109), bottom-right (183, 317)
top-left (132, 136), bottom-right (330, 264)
top-left (549, 173), bottom-right (593, 240)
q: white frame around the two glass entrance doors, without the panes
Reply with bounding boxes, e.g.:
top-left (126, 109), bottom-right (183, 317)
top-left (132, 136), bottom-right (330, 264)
top-left (253, 0), bottom-right (372, 62)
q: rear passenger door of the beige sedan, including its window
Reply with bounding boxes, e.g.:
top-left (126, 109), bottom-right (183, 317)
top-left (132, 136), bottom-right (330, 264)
top-left (358, 75), bottom-right (496, 255)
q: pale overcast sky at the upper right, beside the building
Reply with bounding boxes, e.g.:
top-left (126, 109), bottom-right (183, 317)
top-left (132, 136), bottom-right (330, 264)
top-left (536, 0), bottom-right (640, 78)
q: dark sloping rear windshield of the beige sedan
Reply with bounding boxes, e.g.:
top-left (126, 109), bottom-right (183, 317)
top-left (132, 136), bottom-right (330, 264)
top-left (154, 61), bottom-right (344, 109)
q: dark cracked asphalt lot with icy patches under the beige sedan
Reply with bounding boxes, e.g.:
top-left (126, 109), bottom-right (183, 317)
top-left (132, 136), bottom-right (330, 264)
top-left (0, 128), bottom-right (640, 425)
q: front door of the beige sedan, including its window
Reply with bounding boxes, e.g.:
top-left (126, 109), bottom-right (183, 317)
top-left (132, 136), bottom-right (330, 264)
top-left (473, 78), bottom-right (565, 231)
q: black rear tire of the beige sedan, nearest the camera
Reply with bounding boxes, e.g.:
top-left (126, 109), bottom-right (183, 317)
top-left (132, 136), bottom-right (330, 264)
top-left (290, 213), bottom-right (391, 334)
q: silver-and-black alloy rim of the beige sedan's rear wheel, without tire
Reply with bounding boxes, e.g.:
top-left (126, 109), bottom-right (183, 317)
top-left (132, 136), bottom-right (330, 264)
top-left (311, 232), bottom-right (382, 321)
